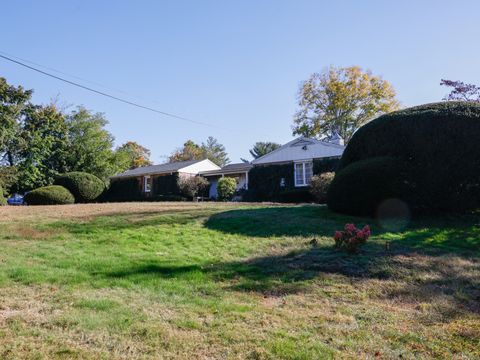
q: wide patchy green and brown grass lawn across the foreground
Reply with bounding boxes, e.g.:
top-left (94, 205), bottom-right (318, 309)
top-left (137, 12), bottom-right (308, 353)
top-left (0, 203), bottom-right (480, 359)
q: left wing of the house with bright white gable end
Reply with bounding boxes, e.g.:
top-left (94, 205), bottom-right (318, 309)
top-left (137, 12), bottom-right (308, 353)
top-left (109, 159), bottom-right (220, 200)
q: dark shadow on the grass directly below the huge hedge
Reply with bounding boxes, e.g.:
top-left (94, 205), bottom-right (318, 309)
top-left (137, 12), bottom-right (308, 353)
top-left (205, 205), bottom-right (480, 255)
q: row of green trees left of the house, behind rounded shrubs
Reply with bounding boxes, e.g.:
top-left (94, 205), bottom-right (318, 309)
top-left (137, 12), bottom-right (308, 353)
top-left (0, 78), bottom-right (150, 192)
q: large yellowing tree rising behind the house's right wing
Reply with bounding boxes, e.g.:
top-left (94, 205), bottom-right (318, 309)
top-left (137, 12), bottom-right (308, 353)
top-left (293, 66), bottom-right (399, 144)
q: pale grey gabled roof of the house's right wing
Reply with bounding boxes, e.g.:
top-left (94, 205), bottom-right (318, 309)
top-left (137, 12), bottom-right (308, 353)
top-left (252, 136), bottom-right (345, 165)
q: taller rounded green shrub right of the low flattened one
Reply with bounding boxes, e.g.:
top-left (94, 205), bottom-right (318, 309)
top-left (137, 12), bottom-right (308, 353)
top-left (55, 172), bottom-right (105, 203)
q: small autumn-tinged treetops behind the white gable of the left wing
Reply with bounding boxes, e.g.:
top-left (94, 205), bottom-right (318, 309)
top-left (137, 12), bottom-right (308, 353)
top-left (168, 136), bottom-right (230, 166)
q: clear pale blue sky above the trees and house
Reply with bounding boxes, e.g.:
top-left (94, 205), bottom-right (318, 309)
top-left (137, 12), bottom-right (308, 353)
top-left (0, 0), bottom-right (480, 163)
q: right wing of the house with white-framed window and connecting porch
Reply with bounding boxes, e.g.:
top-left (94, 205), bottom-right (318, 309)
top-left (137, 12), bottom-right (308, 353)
top-left (200, 137), bottom-right (345, 201)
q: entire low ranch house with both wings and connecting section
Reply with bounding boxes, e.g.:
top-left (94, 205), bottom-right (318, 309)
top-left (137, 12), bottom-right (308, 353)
top-left (108, 137), bottom-right (344, 202)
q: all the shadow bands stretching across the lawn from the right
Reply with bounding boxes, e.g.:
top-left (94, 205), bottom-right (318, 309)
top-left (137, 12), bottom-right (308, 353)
top-left (43, 205), bottom-right (480, 316)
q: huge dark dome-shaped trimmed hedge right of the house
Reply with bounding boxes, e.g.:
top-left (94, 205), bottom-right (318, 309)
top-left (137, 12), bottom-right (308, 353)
top-left (328, 102), bottom-right (480, 215)
